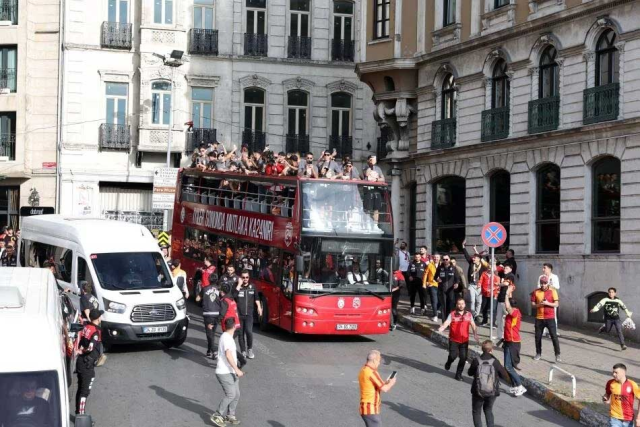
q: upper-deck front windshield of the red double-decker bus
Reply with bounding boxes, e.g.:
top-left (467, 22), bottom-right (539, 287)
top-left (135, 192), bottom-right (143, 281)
top-left (302, 181), bottom-right (392, 237)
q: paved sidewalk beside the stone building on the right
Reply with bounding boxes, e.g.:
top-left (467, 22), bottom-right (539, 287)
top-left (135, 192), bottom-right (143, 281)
top-left (399, 298), bottom-right (640, 427)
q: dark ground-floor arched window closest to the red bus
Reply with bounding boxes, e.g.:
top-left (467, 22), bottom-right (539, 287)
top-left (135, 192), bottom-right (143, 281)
top-left (432, 176), bottom-right (466, 253)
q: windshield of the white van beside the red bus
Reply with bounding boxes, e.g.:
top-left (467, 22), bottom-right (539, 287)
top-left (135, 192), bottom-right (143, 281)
top-left (91, 252), bottom-right (173, 291)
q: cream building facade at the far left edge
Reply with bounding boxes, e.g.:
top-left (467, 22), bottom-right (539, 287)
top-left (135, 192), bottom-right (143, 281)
top-left (0, 0), bottom-right (60, 228)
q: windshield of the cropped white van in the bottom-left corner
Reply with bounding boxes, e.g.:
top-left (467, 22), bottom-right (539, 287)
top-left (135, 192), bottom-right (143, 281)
top-left (0, 371), bottom-right (62, 427)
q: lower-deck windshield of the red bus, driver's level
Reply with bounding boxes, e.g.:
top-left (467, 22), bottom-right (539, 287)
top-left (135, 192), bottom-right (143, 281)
top-left (297, 237), bottom-right (392, 294)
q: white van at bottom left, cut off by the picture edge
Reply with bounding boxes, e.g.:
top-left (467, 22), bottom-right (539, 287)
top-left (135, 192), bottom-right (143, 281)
top-left (0, 267), bottom-right (73, 427)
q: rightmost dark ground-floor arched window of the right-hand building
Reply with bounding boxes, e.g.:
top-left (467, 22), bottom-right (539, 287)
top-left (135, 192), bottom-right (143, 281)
top-left (591, 157), bottom-right (620, 252)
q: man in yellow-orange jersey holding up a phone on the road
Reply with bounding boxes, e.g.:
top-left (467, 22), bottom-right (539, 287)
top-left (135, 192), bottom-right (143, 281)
top-left (358, 350), bottom-right (396, 427)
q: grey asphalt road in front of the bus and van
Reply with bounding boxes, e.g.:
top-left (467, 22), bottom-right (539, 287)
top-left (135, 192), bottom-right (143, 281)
top-left (71, 307), bottom-right (579, 427)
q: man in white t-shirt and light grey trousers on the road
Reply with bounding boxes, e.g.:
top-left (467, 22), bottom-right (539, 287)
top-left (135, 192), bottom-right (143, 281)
top-left (211, 317), bottom-right (244, 427)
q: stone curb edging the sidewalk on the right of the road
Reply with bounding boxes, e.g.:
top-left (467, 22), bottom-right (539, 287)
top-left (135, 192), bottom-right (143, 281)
top-left (398, 313), bottom-right (609, 427)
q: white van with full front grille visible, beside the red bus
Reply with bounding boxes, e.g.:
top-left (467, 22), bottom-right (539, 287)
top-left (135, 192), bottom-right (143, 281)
top-left (18, 215), bottom-right (189, 348)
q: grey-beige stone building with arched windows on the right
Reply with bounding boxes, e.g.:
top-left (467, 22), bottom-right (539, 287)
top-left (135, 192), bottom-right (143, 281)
top-left (357, 0), bottom-right (640, 338)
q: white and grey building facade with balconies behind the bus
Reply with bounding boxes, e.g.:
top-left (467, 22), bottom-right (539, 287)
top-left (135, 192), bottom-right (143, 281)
top-left (61, 0), bottom-right (376, 227)
